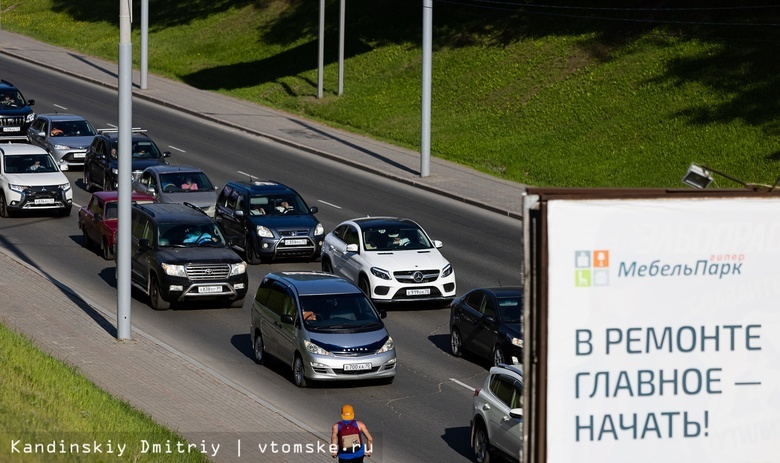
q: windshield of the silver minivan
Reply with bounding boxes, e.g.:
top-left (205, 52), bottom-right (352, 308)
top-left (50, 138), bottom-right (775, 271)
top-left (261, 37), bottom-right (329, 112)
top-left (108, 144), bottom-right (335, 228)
top-left (300, 293), bottom-right (382, 329)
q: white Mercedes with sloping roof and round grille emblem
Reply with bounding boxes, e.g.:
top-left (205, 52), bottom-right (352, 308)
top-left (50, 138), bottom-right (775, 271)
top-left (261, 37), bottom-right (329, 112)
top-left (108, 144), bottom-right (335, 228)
top-left (322, 217), bottom-right (455, 304)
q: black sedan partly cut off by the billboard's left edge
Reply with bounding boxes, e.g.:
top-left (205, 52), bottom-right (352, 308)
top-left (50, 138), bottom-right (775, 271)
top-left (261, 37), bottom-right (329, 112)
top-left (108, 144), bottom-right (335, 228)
top-left (450, 286), bottom-right (523, 365)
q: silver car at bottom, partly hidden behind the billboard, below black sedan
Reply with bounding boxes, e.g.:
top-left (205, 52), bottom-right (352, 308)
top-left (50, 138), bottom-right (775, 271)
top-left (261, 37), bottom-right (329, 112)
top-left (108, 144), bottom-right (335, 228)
top-left (471, 364), bottom-right (523, 463)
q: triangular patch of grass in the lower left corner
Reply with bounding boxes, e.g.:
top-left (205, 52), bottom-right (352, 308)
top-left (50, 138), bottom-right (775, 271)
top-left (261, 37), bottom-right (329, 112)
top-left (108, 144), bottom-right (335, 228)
top-left (0, 324), bottom-right (209, 463)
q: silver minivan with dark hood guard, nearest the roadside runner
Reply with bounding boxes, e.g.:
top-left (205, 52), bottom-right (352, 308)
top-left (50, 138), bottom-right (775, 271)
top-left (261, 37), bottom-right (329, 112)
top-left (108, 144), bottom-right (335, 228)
top-left (250, 271), bottom-right (396, 387)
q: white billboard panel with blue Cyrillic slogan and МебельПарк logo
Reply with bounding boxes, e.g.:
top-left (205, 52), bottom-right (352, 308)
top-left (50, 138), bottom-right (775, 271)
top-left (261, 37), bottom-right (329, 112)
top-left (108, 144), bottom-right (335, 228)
top-left (546, 198), bottom-right (780, 463)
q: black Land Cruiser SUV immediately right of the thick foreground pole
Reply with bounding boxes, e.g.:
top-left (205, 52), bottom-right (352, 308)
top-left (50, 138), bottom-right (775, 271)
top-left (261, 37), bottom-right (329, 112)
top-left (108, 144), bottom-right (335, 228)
top-left (130, 203), bottom-right (248, 310)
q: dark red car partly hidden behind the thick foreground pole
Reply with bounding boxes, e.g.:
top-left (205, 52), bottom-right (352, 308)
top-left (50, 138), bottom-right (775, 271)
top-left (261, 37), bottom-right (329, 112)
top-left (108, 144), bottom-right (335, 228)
top-left (79, 191), bottom-right (154, 260)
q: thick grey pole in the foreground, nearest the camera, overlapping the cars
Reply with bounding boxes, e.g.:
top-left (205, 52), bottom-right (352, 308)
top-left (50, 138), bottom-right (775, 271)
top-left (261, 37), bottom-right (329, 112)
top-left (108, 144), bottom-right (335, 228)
top-left (116, 0), bottom-right (133, 340)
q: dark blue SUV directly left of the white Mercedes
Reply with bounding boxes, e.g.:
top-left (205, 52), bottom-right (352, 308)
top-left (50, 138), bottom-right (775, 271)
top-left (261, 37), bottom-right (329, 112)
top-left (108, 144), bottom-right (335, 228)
top-left (214, 180), bottom-right (325, 264)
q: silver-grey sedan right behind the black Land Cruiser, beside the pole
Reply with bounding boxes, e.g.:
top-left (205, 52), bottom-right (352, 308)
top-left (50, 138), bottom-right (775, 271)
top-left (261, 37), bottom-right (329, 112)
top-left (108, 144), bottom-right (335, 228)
top-left (131, 165), bottom-right (217, 217)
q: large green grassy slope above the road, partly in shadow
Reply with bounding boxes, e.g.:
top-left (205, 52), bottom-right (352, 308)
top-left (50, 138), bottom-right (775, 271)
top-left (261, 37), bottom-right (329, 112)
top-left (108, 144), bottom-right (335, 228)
top-left (2, 0), bottom-right (780, 188)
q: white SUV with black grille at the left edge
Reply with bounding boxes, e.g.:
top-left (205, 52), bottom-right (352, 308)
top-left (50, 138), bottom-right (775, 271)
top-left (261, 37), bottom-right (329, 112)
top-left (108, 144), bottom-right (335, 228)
top-left (0, 144), bottom-right (73, 217)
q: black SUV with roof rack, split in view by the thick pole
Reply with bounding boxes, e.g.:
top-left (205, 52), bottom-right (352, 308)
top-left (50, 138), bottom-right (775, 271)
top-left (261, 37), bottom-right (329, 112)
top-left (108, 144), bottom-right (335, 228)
top-left (83, 128), bottom-right (171, 191)
